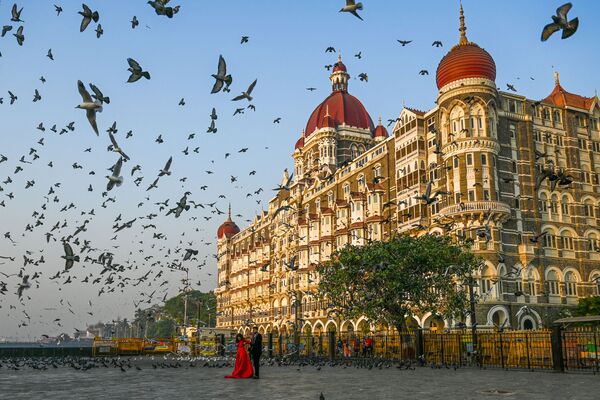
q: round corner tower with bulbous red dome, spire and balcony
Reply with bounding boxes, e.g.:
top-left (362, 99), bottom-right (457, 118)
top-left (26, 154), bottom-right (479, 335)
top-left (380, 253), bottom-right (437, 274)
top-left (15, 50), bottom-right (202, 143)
top-left (428, 4), bottom-right (510, 241)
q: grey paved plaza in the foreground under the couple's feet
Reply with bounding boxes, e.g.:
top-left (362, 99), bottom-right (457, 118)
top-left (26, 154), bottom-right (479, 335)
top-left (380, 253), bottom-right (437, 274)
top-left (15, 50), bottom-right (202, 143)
top-left (0, 360), bottom-right (600, 400)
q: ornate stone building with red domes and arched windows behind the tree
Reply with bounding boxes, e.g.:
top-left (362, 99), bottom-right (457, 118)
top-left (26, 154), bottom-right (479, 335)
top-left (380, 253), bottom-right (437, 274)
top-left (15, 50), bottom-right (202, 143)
top-left (215, 7), bottom-right (600, 332)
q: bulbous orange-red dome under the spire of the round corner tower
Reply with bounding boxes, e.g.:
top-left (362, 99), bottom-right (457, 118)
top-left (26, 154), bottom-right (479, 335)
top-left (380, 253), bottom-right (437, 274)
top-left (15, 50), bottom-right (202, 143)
top-left (435, 43), bottom-right (496, 89)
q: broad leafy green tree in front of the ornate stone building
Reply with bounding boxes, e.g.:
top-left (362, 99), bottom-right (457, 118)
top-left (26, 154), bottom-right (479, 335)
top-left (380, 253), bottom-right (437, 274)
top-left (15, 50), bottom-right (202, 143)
top-left (317, 235), bottom-right (481, 332)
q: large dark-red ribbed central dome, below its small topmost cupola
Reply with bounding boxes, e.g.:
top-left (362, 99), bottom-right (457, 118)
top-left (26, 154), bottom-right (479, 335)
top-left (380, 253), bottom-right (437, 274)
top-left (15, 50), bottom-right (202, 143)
top-left (304, 90), bottom-right (374, 137)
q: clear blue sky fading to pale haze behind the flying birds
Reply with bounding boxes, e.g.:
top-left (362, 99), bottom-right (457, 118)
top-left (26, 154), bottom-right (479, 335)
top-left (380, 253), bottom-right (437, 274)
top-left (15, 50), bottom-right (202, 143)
top-left (0, 0), bottom-right (600, 338)
